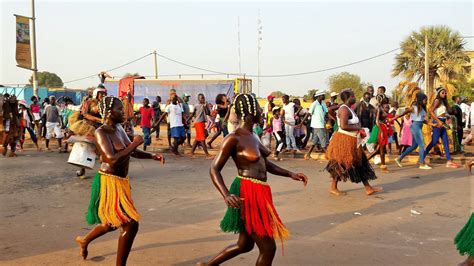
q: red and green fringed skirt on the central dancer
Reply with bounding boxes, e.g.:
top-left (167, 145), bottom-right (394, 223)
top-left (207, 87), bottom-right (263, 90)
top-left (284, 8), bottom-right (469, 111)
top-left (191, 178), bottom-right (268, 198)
top-left (221, 176), bottom-right (289, 240)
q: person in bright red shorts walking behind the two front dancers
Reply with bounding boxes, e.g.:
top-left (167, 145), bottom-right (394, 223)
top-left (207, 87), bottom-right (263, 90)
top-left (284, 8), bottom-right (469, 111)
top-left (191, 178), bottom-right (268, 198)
top-left (186, 93), bottom-right (212, 159)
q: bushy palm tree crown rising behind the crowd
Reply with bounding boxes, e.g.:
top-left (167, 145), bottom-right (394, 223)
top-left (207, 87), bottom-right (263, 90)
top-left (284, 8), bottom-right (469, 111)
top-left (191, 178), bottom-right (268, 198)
top-left (392, 26), bottom-right (469, 95)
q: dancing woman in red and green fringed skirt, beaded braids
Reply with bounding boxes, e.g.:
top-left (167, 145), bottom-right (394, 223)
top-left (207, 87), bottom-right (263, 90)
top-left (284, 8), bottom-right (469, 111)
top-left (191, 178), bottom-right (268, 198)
top-left (201, 94), bottom-right (308, 265)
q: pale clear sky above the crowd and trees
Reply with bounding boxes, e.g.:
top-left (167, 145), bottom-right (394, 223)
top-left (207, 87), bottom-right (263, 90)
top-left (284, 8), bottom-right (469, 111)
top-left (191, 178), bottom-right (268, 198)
top-left (0, 0), bottom-right (474, 96)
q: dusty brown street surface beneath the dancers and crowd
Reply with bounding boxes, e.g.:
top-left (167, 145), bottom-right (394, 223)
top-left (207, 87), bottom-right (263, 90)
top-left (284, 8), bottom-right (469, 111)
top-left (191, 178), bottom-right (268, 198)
top-left (0, 144), bottom-right (474, 265)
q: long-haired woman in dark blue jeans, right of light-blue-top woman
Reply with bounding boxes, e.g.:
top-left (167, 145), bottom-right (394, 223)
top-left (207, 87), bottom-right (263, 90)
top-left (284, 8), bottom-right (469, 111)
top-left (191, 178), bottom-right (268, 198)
top-left (423, 87), bottom-right (459, 168)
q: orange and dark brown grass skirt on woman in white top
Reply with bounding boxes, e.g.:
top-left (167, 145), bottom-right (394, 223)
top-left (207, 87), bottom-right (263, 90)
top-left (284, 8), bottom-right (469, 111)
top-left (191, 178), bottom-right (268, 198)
top-left (326, 132), bottom-right (377, 183)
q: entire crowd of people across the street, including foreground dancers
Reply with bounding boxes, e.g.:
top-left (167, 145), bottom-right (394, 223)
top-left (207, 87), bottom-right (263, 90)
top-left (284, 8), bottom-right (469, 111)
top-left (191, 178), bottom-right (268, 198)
top-left (0, 85), bottom-right (474, 265)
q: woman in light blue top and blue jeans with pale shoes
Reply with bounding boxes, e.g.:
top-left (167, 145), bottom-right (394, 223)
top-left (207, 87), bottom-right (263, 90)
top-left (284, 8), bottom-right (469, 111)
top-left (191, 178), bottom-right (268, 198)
top-left (394, 92), bottom-right (431, 170)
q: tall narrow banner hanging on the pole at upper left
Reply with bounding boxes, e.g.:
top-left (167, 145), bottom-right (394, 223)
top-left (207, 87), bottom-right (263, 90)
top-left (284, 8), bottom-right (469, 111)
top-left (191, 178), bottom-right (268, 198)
top-left (15, 15), bottom-right (32, 69)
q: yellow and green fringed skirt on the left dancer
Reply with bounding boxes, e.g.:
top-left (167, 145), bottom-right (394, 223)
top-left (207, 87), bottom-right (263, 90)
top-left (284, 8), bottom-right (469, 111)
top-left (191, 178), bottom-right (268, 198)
top-left (86, 171), bottom-right (140, 228)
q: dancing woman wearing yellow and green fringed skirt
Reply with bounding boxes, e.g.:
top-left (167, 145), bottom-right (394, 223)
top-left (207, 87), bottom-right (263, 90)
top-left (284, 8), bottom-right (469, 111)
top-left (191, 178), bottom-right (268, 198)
top-left (76, 97), bottom-right (165, 265)
